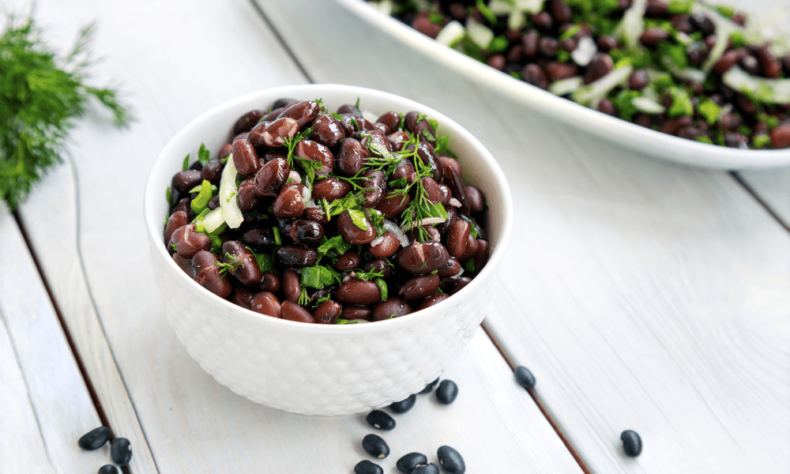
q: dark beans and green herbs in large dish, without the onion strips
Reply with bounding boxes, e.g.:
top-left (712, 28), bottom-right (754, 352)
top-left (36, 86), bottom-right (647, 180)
top-left (369, 0), bottom-right (790, 149)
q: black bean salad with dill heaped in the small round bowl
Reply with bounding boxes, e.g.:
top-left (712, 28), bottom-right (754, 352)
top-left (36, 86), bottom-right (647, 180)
top-left (164, 99), bottom-right (490, 324)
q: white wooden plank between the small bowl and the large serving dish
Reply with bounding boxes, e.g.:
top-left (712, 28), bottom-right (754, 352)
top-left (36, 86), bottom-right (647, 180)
top-left (260, 1), bottom-right (790, 473)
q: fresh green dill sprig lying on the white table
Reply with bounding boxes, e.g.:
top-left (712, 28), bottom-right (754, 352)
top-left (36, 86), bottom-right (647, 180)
top-left (0, 17), bottom-right (131, 210)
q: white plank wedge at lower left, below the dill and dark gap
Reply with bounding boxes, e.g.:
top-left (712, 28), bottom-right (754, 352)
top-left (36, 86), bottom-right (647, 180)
top-left (0, 204), bottom-right (109, 473)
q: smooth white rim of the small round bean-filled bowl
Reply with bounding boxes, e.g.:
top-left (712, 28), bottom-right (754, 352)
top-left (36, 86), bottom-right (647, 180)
top-left (143, 84), bottom-right (513, 335)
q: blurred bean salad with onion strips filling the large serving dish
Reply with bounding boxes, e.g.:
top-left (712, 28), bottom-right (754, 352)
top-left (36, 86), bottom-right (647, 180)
top-left (368, 0), bottom-right (790, 149)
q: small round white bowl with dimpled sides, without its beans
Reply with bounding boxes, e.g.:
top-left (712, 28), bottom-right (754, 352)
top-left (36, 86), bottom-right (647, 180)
top-left (144, 84), bottom-right (513, 415)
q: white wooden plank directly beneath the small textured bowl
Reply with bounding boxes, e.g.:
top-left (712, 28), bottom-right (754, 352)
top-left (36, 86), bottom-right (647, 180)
top-left (12, 0), bottom-right (580, 473)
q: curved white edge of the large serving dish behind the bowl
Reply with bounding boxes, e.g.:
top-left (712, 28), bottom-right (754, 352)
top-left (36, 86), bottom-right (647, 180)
top-left (337, 0), bottom-right (790, 169)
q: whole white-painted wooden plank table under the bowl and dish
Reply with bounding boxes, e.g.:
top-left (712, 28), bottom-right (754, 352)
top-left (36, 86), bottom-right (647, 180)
top-left (0, 0), bottom-right (790, 474)
